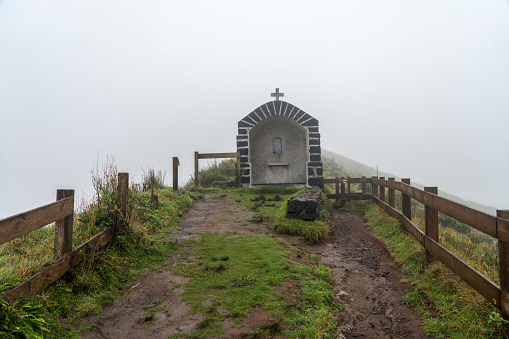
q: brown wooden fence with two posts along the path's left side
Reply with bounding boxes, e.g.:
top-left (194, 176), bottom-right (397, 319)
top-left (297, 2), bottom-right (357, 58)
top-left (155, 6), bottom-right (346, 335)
top-left (0, 173), bottom-right (129, 301)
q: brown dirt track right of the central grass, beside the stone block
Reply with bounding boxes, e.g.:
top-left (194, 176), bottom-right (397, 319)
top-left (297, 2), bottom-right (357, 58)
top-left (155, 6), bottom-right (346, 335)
top-left (284, 210), bottom-right (428, 339)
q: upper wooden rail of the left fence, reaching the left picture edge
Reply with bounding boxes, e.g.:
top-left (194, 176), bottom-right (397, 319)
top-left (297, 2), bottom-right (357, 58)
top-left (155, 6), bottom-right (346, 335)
top-left (0, 197), bottom-right (74, 245)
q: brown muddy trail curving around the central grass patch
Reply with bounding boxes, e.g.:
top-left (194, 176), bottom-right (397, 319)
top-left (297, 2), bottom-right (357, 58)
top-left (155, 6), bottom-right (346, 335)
top-left (76, 195), bottom-right (427, 339)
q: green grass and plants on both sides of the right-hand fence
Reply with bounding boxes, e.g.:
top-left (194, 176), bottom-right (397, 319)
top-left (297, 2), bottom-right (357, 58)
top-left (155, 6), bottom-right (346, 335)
top-left (323, 153), bottom-right (503, 338)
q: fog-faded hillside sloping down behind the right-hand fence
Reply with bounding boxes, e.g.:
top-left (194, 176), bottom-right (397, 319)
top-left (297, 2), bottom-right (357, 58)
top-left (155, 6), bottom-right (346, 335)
top-left (322, 149), bottom-right (496, 215)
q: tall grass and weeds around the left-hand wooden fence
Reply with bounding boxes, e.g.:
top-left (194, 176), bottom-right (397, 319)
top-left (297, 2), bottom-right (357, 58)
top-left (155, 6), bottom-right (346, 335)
top-left (0, 160), bottom-right (192, 338)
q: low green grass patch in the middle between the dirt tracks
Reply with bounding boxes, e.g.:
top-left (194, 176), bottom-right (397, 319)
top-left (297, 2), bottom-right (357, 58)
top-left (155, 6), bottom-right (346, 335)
top-left (172, 233), bottom-right (339, 338)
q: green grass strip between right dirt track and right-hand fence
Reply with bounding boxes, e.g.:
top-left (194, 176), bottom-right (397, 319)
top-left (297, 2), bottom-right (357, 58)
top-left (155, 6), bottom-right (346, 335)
top-left (344, 201), bottom-right (502, 338)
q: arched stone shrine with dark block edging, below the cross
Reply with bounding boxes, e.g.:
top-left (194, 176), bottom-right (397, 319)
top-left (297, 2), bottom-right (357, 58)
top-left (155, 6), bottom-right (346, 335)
top-left (237, 99), bottom-right (323, 188)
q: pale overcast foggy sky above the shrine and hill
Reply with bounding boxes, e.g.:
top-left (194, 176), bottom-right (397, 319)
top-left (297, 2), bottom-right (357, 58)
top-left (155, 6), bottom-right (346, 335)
top-left (0, 0), bottom-right (509, 219)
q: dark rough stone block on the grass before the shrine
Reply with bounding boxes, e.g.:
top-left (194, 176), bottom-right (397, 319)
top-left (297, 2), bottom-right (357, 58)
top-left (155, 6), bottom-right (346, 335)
top-left (286, 188), bottom-right (322, 220)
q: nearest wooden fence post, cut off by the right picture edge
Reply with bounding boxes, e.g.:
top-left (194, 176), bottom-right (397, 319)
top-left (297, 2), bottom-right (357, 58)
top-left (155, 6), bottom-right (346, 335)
top-left (497, 210), bottom-right (509, 338)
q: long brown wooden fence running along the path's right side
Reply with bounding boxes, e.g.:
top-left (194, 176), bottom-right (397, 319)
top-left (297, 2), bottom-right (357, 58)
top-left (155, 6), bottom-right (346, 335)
top-left (324, 177), bottom-right (509, 326)
